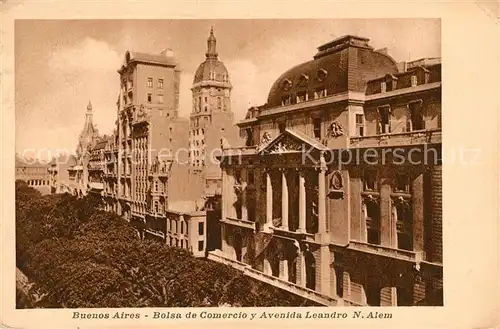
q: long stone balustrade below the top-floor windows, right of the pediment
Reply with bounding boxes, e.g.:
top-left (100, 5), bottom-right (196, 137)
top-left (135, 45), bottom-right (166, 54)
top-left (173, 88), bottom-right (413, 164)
top-left (350, 129), bottom-right (442, 148)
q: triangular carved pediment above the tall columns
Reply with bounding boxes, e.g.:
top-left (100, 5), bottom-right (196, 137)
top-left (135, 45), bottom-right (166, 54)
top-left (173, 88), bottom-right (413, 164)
top-left (259, 129), bottom-right (327, 154)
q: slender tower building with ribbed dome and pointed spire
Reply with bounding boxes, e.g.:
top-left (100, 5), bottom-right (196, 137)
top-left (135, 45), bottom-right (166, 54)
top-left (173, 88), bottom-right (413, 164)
top-left (189, 28), bottom-right (239, 197)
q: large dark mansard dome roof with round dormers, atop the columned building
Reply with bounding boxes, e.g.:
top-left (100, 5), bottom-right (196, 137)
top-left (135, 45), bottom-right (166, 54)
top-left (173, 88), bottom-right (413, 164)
top-left (267, 35), bottom-right (398, 107)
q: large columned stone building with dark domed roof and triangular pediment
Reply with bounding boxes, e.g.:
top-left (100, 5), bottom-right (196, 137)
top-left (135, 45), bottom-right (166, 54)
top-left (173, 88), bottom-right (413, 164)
top-left (213, 36), bottom-right (443, 306)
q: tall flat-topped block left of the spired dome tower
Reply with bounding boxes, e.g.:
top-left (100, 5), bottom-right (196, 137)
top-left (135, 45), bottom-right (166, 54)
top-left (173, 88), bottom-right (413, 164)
top-left (117, 51), bottom-right (192, 221)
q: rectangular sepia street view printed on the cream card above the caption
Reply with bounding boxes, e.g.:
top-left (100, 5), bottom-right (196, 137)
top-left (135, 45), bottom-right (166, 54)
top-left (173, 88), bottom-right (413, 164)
top-left (11, 18), bottom-right (446, 310)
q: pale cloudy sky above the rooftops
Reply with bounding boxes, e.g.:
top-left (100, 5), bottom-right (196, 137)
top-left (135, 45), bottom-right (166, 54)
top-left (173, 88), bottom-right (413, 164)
top-left (15, 19), bottom-right (441, 158)
